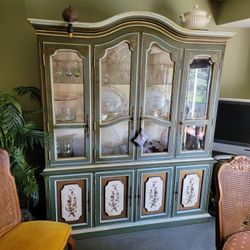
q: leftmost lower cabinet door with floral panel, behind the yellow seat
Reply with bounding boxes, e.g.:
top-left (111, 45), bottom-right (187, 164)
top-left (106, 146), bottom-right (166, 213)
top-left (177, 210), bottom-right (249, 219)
top-left (49, 174), bottom-right (92, 227)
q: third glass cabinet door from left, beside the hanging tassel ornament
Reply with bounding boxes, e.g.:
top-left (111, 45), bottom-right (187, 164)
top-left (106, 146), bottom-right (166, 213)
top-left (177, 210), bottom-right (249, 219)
top-left (138, 34), bottom-right (181, 158)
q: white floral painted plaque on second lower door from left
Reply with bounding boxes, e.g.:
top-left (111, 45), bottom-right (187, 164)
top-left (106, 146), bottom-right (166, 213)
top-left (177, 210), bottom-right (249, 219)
top-left (105, 181), bottom-right (124, 216)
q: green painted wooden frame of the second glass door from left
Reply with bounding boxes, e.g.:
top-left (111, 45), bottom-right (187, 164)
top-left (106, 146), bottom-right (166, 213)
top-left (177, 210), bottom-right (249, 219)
top-left (94, 33), bottom-right (139, 162)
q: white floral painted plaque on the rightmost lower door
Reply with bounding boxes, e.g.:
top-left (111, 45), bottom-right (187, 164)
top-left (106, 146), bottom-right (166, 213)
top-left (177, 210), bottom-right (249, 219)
top-left (181, 174), bottom-right (200, 208)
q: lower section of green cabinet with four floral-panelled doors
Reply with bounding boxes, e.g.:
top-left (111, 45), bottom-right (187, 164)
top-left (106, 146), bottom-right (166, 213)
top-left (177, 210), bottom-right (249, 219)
top-left (46, 164), bottom-right (212, 238)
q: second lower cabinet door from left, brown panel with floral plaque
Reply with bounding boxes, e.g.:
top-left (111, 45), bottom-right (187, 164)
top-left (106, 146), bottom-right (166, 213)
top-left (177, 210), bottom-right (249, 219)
top-left (96, 171), bottom-right (133, 224)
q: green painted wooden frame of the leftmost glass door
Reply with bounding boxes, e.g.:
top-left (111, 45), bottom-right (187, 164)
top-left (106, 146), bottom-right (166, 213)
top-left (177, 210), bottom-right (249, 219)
top-left (40, 41), bottom-right (92, 167)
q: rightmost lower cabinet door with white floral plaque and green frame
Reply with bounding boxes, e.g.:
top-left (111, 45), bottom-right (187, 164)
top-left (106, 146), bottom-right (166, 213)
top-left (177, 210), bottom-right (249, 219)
top-left (174, 165), bottom-right (211, 215)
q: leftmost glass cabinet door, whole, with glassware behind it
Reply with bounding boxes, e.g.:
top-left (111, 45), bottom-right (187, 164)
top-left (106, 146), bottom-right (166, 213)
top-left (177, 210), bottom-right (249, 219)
top-left (44, 43), bottom-right (91, 164)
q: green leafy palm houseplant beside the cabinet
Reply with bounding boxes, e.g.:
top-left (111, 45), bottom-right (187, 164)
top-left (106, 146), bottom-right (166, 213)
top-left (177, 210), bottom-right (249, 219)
top-left (0, 87), bottom-right (47, 210)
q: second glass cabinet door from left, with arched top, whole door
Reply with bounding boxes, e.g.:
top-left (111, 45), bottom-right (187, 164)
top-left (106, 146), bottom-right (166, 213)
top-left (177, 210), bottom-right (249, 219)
top-left (95, 34), bottom-right (138, 161)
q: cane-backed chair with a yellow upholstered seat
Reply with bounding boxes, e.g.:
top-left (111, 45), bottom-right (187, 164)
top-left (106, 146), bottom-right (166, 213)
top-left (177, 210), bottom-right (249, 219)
top-left (0, 149), bottom-right (74, 250)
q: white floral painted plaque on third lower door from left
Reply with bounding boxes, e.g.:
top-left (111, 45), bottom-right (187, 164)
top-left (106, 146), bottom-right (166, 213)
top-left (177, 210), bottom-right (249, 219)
top-left (145, 177), bottom-right (163, 212)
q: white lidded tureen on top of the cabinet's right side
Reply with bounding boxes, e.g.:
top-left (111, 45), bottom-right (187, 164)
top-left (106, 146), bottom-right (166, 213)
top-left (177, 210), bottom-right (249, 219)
top-left (180, 5), bottom-right (211, 29)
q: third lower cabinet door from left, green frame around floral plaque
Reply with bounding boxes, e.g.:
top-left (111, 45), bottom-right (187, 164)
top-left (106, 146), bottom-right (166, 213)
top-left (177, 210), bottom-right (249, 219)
top-left (137, 167), bottom-right (173, 220)
